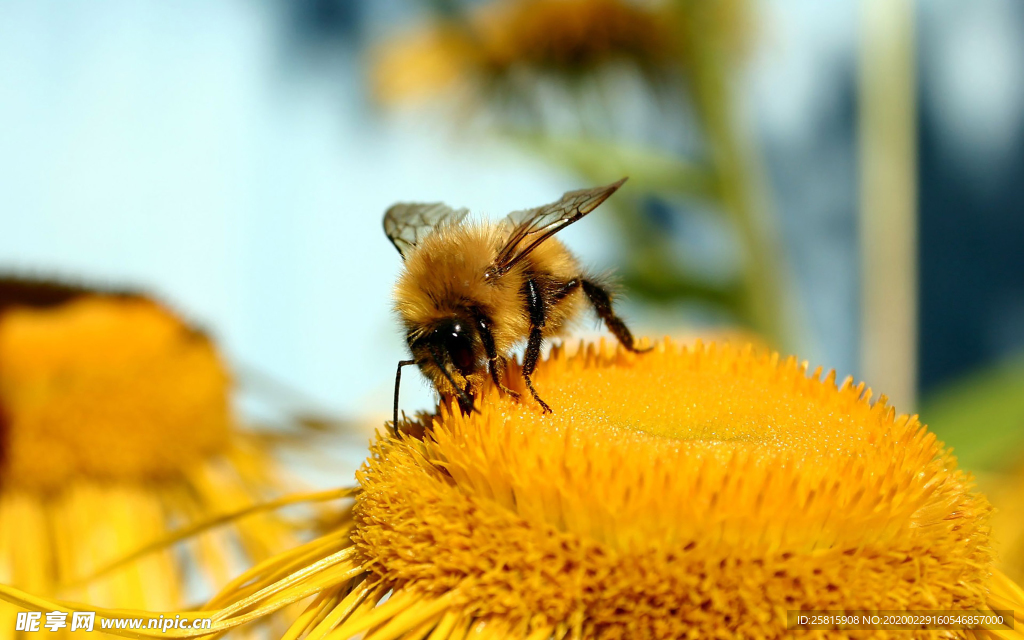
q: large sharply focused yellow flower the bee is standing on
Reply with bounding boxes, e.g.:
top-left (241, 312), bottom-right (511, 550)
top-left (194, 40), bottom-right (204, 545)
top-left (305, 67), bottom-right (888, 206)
top-left (0, 341), bottom-right (1024, 640)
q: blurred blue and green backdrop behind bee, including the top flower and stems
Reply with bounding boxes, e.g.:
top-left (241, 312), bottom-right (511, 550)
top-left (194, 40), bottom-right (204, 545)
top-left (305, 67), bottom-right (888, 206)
top-left (0, 0), bottom-right (1024, 553)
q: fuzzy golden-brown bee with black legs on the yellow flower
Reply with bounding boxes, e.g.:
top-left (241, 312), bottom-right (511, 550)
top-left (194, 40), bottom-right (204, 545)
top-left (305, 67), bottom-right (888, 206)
top-left (384, 178), bottom-right (644, 429)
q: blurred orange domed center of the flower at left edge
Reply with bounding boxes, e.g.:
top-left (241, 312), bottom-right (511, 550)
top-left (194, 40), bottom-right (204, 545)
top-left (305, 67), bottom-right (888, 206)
top-left (0, 294), bottom-right (230, 489)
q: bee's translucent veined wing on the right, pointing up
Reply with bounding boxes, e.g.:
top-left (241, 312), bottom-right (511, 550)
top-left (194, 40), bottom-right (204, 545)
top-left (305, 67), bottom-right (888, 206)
top-left (490, 178), bottom-right (626, 275)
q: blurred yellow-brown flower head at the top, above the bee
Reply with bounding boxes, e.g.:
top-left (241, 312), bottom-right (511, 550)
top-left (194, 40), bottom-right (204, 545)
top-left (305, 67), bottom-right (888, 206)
top-left (374, 0), bottom-right (678, 102)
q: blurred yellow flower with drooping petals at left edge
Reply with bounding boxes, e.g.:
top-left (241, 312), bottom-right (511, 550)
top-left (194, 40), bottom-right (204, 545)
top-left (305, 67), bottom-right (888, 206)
top-left (0, 279), bottom-right (313, 639)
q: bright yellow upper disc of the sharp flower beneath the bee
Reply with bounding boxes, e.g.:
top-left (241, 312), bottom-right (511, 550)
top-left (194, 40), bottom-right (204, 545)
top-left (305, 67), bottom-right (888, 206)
top-left (421, 342), bottom-right (958, 550)
